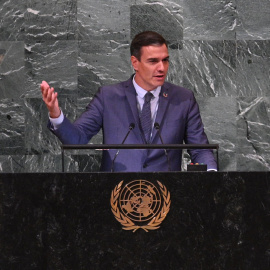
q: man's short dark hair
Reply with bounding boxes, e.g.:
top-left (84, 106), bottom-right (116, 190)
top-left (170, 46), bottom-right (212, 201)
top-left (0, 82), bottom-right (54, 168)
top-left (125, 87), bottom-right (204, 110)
top-left (130, 31), bottom-right (168, 60)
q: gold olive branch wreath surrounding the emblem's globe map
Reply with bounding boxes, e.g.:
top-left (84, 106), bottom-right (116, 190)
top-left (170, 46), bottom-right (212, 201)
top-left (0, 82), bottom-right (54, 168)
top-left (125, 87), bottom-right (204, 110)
top-left (110, 180), bottom-right (171, 232)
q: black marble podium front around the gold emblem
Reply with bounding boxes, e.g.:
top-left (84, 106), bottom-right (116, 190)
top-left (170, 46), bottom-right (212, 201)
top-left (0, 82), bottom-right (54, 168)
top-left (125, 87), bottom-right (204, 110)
top-left (0, 172), bottom-right (270, 270)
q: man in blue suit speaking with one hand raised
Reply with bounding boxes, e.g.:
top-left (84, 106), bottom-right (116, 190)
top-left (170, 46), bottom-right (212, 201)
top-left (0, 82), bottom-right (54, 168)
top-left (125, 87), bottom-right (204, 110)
top-left (41, 31), bottom-right (217, 172)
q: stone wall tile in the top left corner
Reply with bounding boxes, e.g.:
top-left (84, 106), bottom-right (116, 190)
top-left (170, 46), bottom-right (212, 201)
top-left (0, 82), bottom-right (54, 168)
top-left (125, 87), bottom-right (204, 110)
top-left (0, 0), bottom-right (27, 41)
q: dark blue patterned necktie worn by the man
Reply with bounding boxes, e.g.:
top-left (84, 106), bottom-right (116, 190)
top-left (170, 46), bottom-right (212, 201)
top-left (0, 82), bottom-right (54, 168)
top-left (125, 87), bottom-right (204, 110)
top-left (140, 92), bottom-right (153, 143)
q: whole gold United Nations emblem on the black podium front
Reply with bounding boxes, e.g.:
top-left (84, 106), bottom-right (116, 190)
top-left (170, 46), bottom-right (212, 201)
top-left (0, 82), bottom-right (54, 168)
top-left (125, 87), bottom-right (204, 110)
top-left (111, 180), bottom-right (171, 232)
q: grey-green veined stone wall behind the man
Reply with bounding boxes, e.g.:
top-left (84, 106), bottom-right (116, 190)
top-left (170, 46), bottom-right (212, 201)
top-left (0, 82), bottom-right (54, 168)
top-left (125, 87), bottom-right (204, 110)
top-left (0, 0), bottom-right (270, 172)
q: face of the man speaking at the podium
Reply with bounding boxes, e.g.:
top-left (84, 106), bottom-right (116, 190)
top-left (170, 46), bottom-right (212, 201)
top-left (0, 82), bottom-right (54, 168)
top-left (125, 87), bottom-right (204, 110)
top-left (131, 44), bottom-right (169, 91)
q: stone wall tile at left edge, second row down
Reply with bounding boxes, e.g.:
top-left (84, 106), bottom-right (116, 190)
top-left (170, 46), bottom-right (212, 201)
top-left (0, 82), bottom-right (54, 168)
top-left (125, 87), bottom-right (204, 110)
top-left (0, 41), bottom-right (25, 99)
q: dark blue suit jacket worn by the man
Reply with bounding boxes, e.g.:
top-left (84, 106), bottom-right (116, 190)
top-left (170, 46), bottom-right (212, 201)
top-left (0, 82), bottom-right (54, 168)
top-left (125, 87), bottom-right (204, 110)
top-left (49, 77), bottom-right (216, 172)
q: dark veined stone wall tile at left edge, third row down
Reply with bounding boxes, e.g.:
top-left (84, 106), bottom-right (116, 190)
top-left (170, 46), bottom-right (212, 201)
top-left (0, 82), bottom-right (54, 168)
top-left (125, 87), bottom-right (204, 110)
top-left (0, 99), bottom-right (25, 155)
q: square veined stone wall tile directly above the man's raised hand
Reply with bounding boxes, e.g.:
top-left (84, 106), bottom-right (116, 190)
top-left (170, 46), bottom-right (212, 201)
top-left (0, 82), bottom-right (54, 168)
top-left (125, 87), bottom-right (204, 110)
top-left (25, 40), bottom-right (78, 98)
